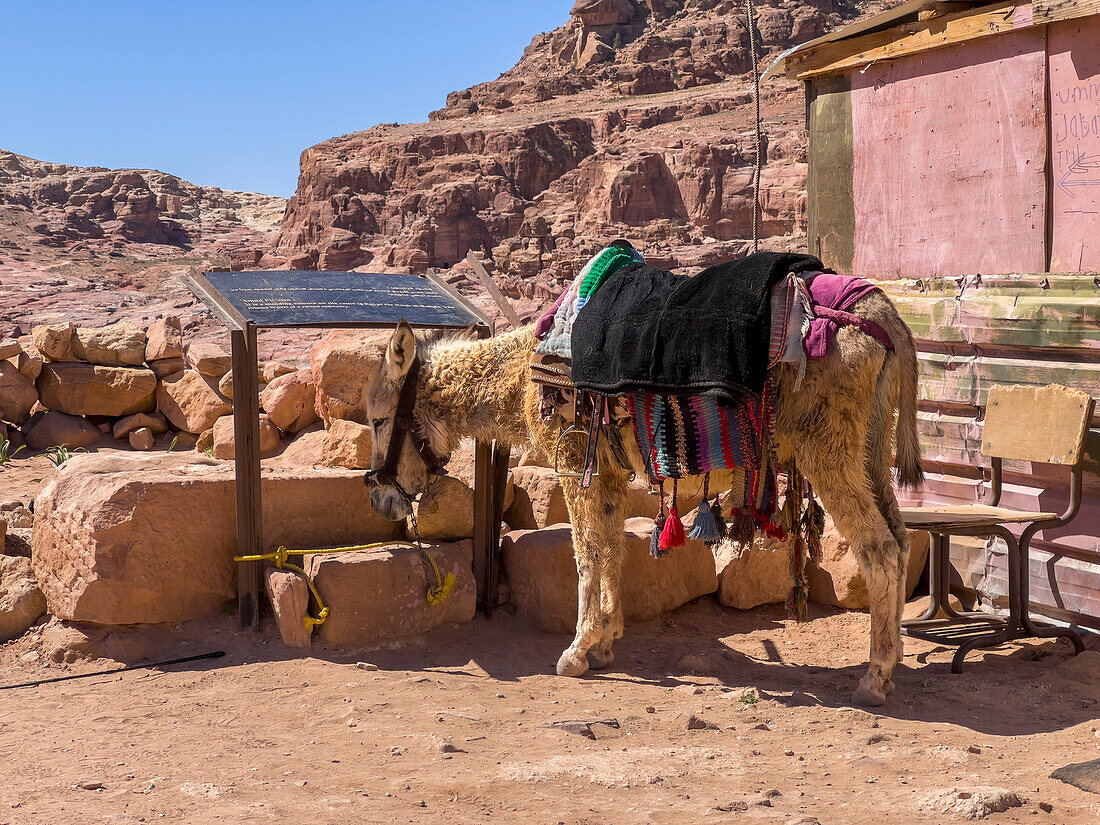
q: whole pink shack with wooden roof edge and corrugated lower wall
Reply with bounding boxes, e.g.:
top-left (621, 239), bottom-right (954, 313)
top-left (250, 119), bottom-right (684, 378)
top-left (766, 0), bottom-right (1100, 627)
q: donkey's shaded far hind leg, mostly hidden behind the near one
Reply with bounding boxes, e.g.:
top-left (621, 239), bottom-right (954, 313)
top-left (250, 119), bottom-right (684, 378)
top-left (867, 358), bottom-right (910, 673)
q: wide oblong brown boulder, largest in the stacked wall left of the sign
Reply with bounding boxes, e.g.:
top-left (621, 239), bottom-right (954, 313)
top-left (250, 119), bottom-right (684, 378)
top-left (37, 362), bottom-right (156, 416)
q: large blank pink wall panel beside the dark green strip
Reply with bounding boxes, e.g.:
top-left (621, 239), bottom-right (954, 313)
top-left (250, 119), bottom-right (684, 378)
top-left (849, 28), bottom-right (1047, 278)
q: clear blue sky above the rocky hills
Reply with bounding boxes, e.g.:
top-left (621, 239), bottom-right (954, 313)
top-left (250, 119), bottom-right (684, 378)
top-left (0, 0), bottom-right (573, 196)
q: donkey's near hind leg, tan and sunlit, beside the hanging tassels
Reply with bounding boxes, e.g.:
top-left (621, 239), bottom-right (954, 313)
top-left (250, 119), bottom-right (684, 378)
top-left (798, 443), bottom-right (901, 706)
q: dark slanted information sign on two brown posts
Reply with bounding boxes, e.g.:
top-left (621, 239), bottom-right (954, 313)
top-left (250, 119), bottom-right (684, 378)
top-left (184, 271), bottom-right (508, 629)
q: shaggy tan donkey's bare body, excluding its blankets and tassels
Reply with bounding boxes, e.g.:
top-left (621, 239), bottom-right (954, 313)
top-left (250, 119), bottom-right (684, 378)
top-left (365, 290), bottom-right (923, 706)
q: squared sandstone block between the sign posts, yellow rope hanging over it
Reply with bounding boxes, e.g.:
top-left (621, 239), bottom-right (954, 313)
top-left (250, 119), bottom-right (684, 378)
top-left (304, 539), bottom-right (477, 647)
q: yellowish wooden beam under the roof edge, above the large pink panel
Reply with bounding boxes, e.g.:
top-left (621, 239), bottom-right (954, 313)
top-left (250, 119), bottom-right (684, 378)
top-left (787, 0), bottom-right (1025, 80)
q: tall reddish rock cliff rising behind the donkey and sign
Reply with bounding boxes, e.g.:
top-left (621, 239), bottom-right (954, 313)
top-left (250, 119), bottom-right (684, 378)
top-left (262, 0), bottom-right (859, 316)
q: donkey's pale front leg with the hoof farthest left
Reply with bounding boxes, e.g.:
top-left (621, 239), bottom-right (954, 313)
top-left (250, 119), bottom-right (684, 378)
top-left (558, 479), bottom-right (620, 677)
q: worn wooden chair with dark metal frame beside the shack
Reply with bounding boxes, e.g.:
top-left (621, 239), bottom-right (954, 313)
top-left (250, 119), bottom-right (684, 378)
top-left (902, 384), bottom-right (1093, 673)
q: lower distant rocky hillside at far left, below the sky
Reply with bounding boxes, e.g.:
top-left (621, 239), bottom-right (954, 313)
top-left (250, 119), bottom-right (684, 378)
top-left (0, 150), bottom-right (286, 338)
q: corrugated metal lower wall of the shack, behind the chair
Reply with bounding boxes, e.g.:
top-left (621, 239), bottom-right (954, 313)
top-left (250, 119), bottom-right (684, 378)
top-left (882, 273), bottom-right (1100, 627)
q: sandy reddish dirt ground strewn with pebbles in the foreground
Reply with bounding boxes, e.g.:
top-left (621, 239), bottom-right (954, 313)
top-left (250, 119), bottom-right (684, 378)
top-left (0, 598), bottom-right (1100, 825)
